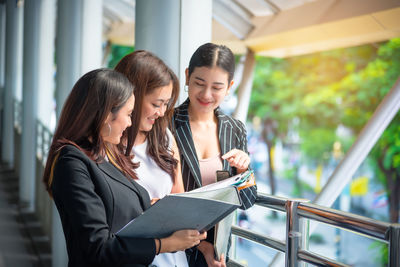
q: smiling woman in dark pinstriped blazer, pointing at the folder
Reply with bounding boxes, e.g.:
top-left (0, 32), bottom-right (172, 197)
top-left (172, 43), bottom-right (256, 266)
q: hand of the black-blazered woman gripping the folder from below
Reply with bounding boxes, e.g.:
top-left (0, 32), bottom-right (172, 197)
top-left (157, 230), bottom-right (207, 253)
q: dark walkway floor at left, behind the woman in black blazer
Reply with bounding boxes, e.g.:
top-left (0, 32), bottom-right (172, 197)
top-left (0, 164), bottom-right (51, 267)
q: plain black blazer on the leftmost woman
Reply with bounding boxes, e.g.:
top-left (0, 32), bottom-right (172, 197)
top-left (51, 145), bottom-right (156, 267)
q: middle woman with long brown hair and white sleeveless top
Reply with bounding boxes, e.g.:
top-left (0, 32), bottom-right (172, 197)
top-left (115, 50), bottom-right (188, 267)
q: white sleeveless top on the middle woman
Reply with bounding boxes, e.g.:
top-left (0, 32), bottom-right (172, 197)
top-left (132, 129), bottom-right (188, 267)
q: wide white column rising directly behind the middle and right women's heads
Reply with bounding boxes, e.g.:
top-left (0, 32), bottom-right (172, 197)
top-left (135, 0), bottom-right (212, 103)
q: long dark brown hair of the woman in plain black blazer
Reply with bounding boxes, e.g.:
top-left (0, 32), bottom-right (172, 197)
top-left (43, 69), bottom-right (136, 194)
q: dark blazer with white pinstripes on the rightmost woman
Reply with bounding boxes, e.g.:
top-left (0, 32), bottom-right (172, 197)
top-left (172, 99), bottom-right (256, 209)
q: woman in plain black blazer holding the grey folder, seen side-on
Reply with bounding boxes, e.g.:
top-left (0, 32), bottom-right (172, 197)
top-left (43, 69), bottom-right (205, 266)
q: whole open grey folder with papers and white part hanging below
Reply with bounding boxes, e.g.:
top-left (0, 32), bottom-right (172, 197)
top-left (116, 170), bottom-right (255, 264)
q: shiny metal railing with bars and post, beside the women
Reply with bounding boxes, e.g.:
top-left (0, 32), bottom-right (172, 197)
top-left (229, 193), bottom-right (400, 267)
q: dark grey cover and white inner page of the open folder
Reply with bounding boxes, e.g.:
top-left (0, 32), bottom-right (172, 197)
top-left (116, 185), bottom-right (241, 238)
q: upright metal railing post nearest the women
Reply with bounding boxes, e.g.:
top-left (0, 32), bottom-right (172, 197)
top-left (285, 199), bottom-right (308, 267)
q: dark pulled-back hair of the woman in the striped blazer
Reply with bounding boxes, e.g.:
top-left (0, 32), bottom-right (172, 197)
top-left (189, 43), bottom-right (235, 83)
